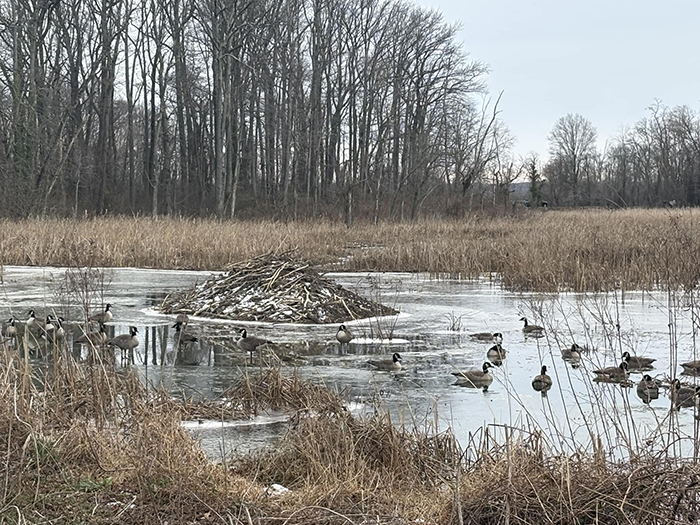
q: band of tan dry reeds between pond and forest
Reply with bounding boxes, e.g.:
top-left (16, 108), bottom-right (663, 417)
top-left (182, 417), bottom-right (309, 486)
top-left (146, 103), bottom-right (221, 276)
top-left (0, 209), bottom-right (700, 291)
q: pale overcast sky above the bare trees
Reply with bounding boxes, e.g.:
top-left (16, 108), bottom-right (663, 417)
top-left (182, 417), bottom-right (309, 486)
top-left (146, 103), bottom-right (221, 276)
top-left (414, 0), bottom-right (700, 160)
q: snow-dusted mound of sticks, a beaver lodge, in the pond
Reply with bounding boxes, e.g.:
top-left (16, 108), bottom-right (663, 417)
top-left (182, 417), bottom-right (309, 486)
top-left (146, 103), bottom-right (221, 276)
top-left (161, 254), bottom-right (398, 324)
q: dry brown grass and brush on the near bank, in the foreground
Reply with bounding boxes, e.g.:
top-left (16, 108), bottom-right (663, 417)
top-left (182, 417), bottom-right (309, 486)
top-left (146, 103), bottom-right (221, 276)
top-left (0, 349), bottom-right (700, 525)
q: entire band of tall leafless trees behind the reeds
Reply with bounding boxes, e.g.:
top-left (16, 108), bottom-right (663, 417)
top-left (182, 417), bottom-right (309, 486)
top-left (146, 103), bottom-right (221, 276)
top-left (0, 0), bottom-right (700, 222)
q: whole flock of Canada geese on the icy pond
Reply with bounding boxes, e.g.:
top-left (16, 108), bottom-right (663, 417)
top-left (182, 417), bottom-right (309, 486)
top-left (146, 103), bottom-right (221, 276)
top-left (2, 303), bottom-right (700, 408)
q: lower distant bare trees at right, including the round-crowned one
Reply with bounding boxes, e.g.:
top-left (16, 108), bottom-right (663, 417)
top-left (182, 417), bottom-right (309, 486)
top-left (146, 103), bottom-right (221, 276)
top-left (548, 103), bottom-right (700, 207)
